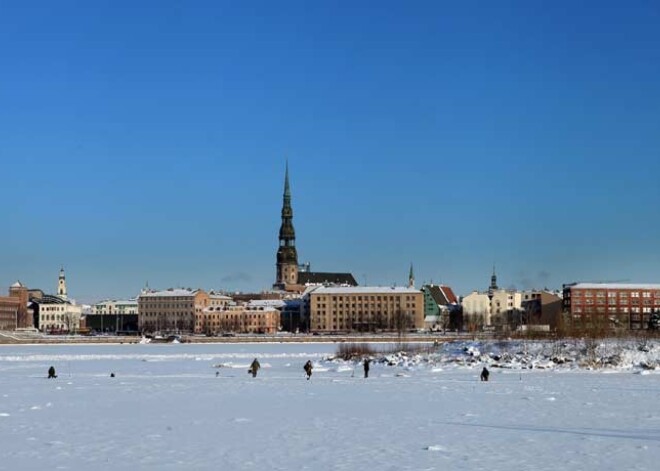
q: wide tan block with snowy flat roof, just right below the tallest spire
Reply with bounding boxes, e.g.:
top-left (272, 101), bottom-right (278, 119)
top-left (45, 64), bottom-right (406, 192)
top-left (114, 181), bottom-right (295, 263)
top-left (309, 286), bottom-right (424, 332)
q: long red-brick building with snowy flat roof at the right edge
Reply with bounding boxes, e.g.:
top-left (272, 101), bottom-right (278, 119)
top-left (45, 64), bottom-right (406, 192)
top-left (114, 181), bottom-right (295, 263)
top-left (564, 283), bottom-right (660, 330)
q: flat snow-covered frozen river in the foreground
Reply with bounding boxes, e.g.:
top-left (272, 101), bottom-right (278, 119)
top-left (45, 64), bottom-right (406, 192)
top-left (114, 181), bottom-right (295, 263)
top-left (0, 344), bottom-right (660, 471)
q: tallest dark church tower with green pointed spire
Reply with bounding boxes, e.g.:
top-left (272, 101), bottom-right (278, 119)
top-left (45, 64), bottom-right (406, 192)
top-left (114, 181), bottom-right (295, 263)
top-left (273, 162), bottom-right (298, 289)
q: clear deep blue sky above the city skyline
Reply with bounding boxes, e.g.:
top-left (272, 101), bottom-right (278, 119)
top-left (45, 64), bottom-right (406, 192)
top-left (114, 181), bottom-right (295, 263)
top-left (0, 1), bottom-right (660, 302)
